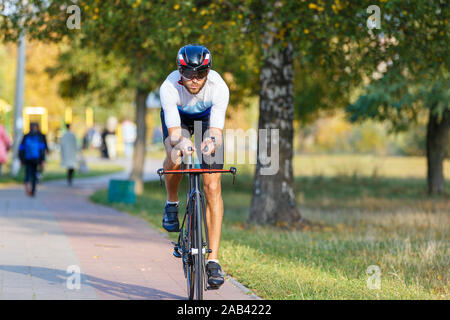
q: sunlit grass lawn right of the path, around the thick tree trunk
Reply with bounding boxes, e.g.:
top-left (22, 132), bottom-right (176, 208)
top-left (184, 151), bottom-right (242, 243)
top-left (92, 155), bottom-right (450, 299)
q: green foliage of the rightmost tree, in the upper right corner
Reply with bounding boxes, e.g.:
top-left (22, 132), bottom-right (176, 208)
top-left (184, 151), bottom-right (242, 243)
top-left (347, 1), bottom-right (450, 126)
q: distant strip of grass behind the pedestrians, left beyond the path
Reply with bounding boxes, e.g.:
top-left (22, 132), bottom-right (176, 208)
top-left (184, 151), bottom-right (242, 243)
top-left (0, 160), bottom-right (124, 185)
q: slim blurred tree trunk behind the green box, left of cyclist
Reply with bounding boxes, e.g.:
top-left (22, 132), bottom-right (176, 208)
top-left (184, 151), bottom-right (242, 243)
top-left (130, 89), bottom-right (147, 194)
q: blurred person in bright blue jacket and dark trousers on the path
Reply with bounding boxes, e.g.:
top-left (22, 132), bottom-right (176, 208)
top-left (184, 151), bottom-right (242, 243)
top-left (19, 122), bottom-right (48, 197)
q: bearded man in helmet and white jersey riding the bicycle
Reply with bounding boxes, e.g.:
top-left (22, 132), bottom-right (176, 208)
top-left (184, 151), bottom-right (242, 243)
top-left (160, 44), bottom-right (229, 288)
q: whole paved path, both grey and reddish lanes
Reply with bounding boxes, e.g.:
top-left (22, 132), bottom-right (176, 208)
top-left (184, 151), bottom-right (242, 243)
top-left (0, 161), bottom-right (252, 300)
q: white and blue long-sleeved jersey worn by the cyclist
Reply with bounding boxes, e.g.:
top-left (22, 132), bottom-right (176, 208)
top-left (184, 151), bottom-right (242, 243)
top-left (159, 70), bottom-right (230, 129)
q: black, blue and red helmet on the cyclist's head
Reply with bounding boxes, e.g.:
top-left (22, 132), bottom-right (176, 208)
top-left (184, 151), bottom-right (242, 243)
top-left (177, 44), bottom-right (212, 79)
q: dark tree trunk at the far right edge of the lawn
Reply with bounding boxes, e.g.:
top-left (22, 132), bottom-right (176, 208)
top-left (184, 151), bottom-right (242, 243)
top-left (427, 107), bottom-right (450, 195)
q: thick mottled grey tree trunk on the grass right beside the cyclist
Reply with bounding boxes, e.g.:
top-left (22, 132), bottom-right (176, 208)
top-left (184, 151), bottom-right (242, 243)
top-left (249, 33), bottom-right (302, 227)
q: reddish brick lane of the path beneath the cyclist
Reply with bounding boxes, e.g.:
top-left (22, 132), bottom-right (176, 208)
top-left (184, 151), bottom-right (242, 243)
top-left (41, 185), bottom-right (253, 300)
